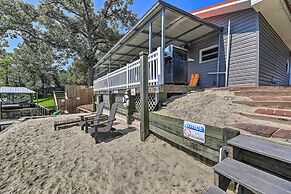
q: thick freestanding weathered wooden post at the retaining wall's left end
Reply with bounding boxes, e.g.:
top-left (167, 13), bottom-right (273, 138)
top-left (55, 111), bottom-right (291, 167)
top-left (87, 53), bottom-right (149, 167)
top-left (139, 52), bottom-right (149, 141)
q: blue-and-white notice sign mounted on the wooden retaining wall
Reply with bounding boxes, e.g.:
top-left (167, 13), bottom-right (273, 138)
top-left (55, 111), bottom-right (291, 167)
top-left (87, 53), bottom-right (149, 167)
top-left (183, 121), bottom-right (205, 143)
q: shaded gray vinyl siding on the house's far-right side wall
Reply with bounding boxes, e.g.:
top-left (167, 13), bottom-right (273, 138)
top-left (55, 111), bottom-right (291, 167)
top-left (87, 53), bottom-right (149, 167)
top-left (259, 15), bottom-right (290, 86)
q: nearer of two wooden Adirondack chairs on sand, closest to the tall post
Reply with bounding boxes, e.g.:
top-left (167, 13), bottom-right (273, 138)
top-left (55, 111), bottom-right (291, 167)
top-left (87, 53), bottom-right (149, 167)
top-left (89, 102), bottom-right (118, 143)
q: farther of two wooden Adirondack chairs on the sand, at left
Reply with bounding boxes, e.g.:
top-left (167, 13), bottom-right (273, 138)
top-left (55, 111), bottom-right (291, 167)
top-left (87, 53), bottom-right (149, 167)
top-left (80, 102), bottom-right (107, 133)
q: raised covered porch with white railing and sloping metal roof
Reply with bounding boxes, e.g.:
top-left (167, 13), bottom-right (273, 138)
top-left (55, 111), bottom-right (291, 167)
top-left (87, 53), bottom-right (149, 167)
top-left (94, 1), bottom-right (222, 93)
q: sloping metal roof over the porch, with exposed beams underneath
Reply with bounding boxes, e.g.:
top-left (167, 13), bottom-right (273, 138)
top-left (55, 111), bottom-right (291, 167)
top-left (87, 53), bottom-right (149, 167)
top-left (94, 0), bottom-right (222, 69)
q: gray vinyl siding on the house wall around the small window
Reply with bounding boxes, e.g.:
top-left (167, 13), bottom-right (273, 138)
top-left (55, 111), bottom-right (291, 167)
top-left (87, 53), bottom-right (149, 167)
top-left (189, 9), bottom-right (259, 87)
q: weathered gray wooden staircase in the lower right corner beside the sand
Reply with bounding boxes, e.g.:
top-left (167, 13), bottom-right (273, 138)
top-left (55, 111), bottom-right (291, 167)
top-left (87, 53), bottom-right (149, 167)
top-left (204, 135), bottom-right (291, 194)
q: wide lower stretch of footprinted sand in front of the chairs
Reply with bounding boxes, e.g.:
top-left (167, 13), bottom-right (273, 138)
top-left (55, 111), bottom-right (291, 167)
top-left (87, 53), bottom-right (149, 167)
top-left (0, 116), bottom-right (213, 194)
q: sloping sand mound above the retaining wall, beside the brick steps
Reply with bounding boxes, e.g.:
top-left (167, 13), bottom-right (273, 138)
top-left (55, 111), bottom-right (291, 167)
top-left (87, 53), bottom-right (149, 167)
top-left (159, 90), bottom-right (256, 127)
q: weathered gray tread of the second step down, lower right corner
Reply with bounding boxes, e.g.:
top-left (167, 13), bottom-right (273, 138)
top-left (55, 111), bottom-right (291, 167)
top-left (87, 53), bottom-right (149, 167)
top-left (213, 158), bottom-right (291, 194)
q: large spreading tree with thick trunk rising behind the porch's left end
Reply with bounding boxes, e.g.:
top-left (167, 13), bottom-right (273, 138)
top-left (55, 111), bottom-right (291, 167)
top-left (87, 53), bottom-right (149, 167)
top-left (0, 0), bottom-right (136, 85)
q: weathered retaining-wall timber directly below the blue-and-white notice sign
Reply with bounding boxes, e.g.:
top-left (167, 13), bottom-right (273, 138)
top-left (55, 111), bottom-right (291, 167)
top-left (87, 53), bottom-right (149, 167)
top-left (149, 125), bottom-right (219, 162)
